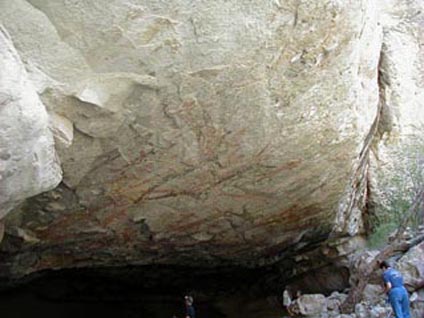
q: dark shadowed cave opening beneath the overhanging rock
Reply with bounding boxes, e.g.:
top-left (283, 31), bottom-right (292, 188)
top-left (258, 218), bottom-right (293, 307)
top-left (0, 266), bottom-right (283, 318)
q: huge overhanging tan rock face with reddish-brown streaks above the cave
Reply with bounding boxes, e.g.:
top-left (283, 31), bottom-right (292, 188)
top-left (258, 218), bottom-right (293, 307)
top-left (0, 0), bottom-right (422, 275)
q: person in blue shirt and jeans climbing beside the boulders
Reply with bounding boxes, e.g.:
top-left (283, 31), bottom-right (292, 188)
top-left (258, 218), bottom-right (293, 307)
top-left (380, 261), bottom-right (410, 318)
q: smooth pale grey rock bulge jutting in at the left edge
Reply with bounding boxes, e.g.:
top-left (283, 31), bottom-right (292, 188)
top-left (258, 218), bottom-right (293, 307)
top-left (0, 26), bottom-right (62, 219)
